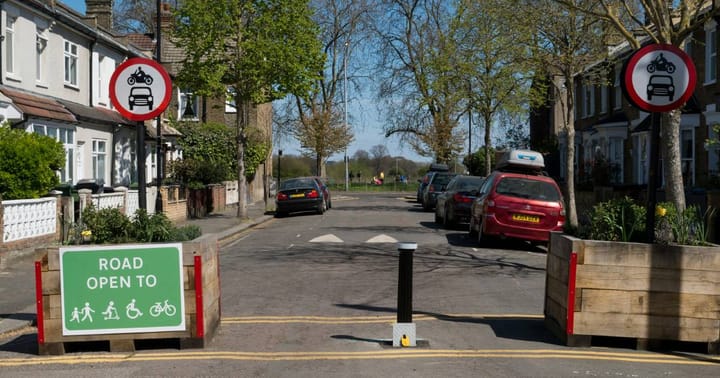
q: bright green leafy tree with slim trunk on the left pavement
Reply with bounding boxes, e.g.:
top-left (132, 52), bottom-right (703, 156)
top-left (172, 0), bottom-right (324, 218)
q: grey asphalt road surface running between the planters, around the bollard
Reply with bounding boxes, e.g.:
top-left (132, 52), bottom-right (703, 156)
top-left (0, 193), bottom-right (720, 377)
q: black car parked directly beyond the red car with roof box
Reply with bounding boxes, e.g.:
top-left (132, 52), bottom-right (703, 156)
top-left (435, 175), bottom-right (485, 227)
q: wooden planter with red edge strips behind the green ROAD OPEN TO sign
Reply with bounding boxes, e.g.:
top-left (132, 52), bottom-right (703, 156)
top-left (35, 235), bottom-right (220, 355)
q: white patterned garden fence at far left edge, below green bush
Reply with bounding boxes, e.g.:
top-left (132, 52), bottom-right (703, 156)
top-left (2, 197), bottom-right (58, 242)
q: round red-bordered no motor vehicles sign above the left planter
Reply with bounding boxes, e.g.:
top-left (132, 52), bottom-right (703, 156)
top-left (110, 58), bottom-right (172, 121)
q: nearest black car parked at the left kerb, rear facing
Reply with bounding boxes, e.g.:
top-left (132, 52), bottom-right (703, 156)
top-left (275, 177), bottom-right (327, 217)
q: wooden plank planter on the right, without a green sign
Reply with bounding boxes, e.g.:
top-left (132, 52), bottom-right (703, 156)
top-left (544, 232), bottom-right (720, 354)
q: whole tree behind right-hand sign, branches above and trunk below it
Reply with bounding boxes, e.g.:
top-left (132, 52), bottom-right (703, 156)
top-left (555, 0), bottom-right (720, 211)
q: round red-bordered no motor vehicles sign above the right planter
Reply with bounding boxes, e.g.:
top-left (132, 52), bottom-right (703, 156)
top-left (622, 44), bottom-right (697, 112)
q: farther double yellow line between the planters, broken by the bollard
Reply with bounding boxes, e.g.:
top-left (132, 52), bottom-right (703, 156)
top-left (222, 314), bottom-right (543, 324)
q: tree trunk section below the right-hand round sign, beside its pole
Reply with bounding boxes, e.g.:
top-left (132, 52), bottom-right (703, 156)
top-left (660, 110), bottom-right (685, 211)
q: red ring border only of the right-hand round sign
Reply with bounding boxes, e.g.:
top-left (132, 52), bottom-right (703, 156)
top-left (623, 43), bottom-right (697, 112)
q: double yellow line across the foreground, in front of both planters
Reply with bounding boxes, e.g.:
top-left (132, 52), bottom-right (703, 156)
top-left (0, 349), bottom-right (720, 367)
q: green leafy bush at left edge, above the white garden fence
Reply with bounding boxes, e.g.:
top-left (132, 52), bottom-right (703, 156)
top-left (0, 126), bottom-right (65, 200)
